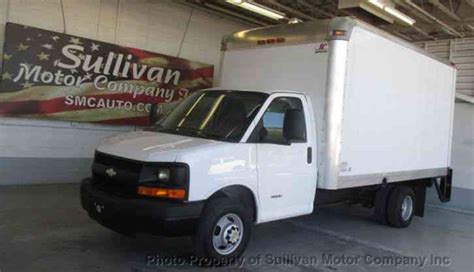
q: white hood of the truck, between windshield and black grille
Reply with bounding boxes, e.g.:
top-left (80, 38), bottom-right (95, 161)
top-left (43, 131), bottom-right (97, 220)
top-left (97, 131), bottom-right (219, 162)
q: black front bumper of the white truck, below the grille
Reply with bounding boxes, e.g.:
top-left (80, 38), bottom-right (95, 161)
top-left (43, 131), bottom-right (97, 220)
top-left (81, 178), bottom-right (204, 236)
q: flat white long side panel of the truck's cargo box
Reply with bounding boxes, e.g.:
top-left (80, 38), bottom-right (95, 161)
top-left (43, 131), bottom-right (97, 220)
top-left (338, 27), bottom-right (455, 188)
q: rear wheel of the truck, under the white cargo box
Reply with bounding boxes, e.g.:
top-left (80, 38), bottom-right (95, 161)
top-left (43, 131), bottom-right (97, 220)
top-left (387, 186), bottom-right (416, 228)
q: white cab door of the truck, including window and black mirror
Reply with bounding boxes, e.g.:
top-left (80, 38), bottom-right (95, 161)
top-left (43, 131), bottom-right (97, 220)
top-left (248, 94), bottom-right (317, 222)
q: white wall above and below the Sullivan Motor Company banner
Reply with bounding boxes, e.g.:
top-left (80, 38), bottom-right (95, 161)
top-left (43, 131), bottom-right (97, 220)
top-left (0, 0), bottom-right (253, 185)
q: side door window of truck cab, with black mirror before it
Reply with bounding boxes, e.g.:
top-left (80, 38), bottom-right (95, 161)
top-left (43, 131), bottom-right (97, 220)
top-left (249, 97), bottom-right (306, 144)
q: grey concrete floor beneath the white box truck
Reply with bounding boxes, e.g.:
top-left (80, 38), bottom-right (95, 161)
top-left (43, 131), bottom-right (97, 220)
top-left (0, 184), bottom-right (474, 272)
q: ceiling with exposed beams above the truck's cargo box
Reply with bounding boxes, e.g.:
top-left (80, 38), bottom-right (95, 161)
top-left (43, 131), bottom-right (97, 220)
top-left (186, 0), bottom-right (474, 42)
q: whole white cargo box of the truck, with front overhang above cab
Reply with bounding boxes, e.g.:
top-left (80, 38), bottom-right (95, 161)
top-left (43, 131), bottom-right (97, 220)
top-left (218, 18), bottom-right (456, 189)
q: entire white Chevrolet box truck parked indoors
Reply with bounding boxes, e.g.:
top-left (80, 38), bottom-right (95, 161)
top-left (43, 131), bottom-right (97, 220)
top-left (81, 18), bottom-right (456, 259)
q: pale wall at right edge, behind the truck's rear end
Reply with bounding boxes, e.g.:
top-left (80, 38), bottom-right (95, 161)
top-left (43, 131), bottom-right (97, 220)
top-left (418, 38), bottom-right (474, 210)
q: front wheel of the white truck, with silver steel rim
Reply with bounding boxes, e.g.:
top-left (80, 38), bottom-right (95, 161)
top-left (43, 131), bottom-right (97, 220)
top-left (194, 197), bottom-right (253, 260)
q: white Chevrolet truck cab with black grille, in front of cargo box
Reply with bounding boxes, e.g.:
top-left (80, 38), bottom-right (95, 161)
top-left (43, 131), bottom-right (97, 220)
top-left (82, 89), bottom-right (317, 260)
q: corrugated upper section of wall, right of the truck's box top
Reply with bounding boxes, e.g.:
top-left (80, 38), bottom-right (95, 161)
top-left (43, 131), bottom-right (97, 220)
top-left (418, 38), bottom-right (474, 96)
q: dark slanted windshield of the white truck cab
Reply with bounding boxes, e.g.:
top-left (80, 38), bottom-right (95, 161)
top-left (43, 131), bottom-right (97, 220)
top-left (152, 90), bottom-right (268, 142)
